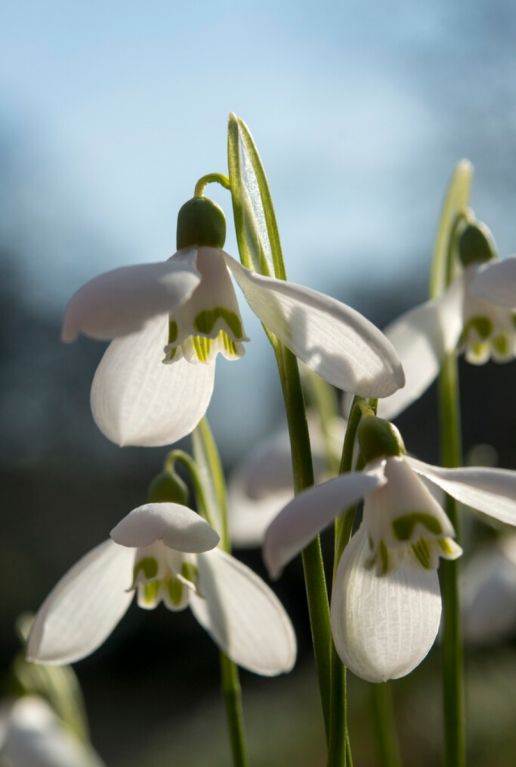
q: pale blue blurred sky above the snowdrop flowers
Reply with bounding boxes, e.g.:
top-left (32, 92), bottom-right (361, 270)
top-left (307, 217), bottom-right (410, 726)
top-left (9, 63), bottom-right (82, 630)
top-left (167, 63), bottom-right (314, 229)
top-left (0, 0), bottom-right (516, 452)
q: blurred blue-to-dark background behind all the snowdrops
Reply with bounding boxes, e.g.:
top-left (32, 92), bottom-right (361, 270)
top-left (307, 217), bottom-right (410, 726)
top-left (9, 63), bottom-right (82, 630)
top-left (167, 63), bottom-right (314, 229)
top-left (0, 0), bottom-right (516, 767)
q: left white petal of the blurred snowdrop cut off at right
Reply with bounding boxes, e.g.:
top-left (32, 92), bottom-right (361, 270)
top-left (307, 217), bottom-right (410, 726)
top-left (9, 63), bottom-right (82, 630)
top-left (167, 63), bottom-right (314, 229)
top-left (378, 278), bottom-right (464, 419)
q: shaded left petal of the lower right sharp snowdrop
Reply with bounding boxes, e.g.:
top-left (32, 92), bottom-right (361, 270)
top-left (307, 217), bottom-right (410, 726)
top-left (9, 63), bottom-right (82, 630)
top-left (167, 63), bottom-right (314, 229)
top-left (263, 461), bottom-right (386, 578)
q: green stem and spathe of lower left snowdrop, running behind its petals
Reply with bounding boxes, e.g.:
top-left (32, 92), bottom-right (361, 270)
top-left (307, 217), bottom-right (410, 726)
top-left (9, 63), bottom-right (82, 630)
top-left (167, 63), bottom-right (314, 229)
top-left (192, 418), bottom-right (249, 767)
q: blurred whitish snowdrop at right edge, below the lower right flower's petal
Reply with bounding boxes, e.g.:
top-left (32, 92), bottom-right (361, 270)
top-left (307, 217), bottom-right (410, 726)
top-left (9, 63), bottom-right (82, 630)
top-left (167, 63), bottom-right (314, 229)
top-left (461, 533), bottom-right (516, 645)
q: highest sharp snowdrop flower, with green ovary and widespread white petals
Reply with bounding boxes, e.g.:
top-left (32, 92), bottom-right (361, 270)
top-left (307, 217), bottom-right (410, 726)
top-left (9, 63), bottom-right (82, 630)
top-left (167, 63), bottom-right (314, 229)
top-left (62, 197), bottom-right (404, 446)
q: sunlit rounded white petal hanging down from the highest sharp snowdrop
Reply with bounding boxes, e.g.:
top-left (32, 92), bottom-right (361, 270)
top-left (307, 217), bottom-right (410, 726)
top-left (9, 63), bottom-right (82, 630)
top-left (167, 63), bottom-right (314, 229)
top-left (91, 316), bottom-right (215, 447)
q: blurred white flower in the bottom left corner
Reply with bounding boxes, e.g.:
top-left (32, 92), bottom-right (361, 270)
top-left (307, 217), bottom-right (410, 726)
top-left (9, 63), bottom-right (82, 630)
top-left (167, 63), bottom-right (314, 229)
top-left (0, 695), bottom-right (104, 767)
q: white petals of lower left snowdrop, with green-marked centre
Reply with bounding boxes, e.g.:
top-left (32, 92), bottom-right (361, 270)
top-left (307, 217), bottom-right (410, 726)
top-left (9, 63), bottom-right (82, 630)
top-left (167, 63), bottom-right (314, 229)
top-left (27, 503), bottom-right (296, 676)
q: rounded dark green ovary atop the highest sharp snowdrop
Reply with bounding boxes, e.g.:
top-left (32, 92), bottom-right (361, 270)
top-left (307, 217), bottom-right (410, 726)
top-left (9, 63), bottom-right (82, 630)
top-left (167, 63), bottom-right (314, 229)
top-left (177, 197), bottom-right (226, 250)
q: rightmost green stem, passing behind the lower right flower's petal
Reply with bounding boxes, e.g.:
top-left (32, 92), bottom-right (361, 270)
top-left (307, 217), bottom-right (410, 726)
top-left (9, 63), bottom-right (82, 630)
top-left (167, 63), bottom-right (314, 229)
top-left (439, 354), bottom-right (466, 767)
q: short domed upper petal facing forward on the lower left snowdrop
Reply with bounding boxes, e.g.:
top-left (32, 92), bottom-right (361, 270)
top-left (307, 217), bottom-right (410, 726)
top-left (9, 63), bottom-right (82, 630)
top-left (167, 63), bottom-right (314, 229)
top-left (110, 503), bottom-right (219, 554)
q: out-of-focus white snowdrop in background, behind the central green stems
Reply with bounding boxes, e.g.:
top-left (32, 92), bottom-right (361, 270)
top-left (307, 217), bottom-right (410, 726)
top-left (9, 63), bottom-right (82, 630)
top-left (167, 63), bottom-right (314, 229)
top-left (228, 418), bottom-right (346, 548)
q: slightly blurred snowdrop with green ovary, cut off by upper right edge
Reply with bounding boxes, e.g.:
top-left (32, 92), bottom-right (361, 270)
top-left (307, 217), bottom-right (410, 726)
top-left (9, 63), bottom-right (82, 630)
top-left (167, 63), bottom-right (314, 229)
top-left (378, 222), bottom-right (516, 418)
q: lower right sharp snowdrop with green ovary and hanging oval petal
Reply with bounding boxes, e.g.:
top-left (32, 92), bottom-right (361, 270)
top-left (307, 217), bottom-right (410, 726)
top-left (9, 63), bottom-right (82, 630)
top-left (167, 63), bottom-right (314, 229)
top-left (264, 416), bottom-right (516, 682)
